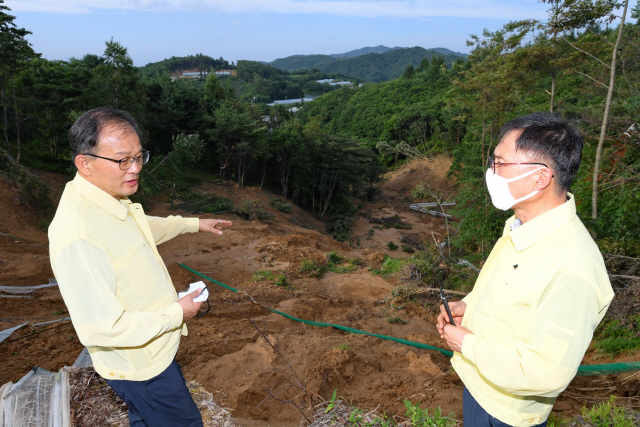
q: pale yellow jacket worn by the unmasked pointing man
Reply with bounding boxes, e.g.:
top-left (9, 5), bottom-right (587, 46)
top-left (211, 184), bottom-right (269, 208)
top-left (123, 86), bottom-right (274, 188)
top-left (49, 174), bottom-right (199, 381)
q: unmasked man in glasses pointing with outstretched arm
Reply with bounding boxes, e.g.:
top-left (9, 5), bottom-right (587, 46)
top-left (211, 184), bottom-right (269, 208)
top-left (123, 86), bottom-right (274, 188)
top-left (49, 108), bottom-right (231, 427)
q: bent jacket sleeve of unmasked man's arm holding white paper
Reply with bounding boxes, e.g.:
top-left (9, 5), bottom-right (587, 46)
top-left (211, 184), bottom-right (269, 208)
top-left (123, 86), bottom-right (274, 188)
top-left (51, 239), bottom-right (183, 347)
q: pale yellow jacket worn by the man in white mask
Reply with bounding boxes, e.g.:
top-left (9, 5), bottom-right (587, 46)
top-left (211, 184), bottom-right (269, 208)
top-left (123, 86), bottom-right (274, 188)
top-left (451, 194), bottom-right (613, 426)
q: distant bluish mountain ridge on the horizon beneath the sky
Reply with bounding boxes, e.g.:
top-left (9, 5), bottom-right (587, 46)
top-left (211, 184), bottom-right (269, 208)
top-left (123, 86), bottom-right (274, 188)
top-left (271, 46), bottom-right (466, 82)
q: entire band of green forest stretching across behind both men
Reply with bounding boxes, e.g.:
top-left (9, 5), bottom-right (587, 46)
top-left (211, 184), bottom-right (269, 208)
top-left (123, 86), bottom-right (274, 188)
top-left (0, 2), bottom-right (640, 256)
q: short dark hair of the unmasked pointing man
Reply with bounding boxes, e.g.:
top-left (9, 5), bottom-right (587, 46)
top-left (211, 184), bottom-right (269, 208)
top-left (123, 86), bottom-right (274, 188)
top-left (69, 107), bottom-right (142, 164)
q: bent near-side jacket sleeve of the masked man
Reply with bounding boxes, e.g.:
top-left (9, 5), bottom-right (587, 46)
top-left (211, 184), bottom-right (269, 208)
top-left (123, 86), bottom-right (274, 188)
top-left (462, 272), bottom-right (603, 397)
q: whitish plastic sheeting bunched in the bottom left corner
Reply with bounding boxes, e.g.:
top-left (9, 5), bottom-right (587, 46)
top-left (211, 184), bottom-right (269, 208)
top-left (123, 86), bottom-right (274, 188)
top-left (0, 368), bottom-right (71, 427)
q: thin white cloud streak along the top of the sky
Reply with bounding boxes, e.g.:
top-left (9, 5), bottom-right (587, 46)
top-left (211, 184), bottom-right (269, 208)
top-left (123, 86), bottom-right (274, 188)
top-left (11, 0), bottom-right (546, 19)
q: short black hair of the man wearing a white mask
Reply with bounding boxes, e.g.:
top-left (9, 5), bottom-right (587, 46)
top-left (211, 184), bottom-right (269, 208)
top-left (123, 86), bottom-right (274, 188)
top-left (500, 113), bottom-right (584, 191)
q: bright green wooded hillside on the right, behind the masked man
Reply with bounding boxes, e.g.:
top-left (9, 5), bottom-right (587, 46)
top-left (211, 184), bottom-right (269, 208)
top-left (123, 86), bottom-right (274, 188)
top-left (299, 3), bottom-right (640, 256)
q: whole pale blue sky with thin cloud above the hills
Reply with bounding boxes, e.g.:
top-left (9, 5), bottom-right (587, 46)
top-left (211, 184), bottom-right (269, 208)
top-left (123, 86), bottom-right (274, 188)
top-left (4, 0), bottom-right (639, 66)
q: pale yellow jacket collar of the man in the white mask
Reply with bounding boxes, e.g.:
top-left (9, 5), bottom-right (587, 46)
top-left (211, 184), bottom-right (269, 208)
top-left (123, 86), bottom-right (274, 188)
top-left (503, 193), bottom-right (576, 252)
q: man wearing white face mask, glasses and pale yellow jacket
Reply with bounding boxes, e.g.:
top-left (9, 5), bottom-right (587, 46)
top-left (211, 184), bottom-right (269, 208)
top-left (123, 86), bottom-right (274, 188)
top-left (437, 113), bottom-right (613, 427)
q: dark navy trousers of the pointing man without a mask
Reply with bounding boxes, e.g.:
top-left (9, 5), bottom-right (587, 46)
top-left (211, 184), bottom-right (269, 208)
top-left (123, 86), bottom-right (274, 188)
top-left (107, 360), bottom-right (202, 427)
